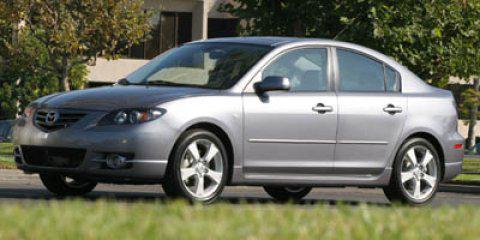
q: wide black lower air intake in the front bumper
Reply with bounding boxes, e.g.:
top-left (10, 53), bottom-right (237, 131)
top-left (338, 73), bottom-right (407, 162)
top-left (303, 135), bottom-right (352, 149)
top-left (21, 146), bottom-right (86, 168)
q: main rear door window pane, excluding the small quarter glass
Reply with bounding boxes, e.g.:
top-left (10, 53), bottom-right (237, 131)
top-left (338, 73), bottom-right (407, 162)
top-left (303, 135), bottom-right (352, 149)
top-left (337, 49), bottom-right (385, 92)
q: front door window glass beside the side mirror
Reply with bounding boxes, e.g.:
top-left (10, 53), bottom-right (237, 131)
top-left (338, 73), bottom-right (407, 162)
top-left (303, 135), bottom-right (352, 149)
top-left (262, 48), bottom-right (328, 92)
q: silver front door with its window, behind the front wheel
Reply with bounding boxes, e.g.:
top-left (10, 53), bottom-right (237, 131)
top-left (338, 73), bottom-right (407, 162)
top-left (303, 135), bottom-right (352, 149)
top-left (243, 48), bottom-right (337, 178)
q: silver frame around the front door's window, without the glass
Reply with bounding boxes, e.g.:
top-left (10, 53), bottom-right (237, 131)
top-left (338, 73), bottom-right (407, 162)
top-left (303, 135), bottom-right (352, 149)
top-left (242, 45), bottom-right (335, 94)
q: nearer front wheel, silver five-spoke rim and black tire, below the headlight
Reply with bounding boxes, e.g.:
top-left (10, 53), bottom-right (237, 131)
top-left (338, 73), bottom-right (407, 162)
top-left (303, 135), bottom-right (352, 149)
top-left (162, 129), bottom-right (229, 203)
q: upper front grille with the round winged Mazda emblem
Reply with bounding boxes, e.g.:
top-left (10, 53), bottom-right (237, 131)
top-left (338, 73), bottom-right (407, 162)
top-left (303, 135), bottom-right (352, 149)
top-left (34, 110), bottom-right (86, 131)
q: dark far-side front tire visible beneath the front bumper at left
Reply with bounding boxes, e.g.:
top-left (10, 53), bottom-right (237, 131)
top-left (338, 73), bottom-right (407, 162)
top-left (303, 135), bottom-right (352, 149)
top-left (40, 173), bottom-right (97, 197)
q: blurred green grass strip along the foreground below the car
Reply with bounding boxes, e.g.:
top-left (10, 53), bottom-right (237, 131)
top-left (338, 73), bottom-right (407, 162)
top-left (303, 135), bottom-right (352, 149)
top-left (0, 201), bottom-right (480, 240)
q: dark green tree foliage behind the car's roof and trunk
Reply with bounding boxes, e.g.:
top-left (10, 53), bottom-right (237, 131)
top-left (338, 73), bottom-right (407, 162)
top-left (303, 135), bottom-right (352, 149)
top-left (220, 0), bottom-right (480, 87)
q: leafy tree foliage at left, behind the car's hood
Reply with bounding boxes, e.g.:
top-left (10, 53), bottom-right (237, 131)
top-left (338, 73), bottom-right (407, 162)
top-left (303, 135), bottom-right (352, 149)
top-left (0, 0), bottom-right (149, 119)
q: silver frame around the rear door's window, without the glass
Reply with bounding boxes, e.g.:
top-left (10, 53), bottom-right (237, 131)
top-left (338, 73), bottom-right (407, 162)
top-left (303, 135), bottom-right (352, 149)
top-left (332, 47), bottom-right (402, 93)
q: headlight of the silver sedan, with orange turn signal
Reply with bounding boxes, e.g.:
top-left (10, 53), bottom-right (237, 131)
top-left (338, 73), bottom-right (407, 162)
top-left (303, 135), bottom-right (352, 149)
top-left (98, 108), bottom-right (166, 126)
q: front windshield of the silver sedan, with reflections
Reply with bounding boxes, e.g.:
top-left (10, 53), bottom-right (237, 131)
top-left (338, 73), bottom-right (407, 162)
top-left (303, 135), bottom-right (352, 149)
top-left (127, 43), bottom-right (271, 89)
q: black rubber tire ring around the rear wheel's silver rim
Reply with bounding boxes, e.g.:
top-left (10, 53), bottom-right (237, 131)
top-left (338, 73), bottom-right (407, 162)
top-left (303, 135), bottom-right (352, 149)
top-left (394, 138), bottom-right (442, 205)
